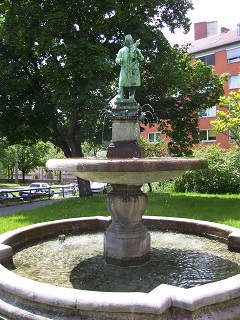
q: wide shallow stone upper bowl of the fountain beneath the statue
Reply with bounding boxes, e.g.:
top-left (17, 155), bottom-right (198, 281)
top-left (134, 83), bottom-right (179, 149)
top-left (46, 157), bottom-right (207, 185)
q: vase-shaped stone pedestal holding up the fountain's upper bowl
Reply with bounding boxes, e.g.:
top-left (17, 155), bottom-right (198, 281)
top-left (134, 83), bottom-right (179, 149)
top-left (104, 185), bottom-right (150, 266)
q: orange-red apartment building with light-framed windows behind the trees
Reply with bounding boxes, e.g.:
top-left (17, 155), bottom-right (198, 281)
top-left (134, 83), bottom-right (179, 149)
top-left (142, 21), bottom-right (240, 148)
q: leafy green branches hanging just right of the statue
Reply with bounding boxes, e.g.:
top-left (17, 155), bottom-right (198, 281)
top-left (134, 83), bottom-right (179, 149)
top-left (141, 52), bottom-right (226, 156)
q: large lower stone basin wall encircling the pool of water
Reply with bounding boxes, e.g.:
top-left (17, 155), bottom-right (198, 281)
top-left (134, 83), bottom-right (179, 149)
top-left (0, 216), bottom-right (240, 320)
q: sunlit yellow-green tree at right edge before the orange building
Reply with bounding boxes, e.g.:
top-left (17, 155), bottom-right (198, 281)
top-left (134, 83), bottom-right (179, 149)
top-left (211, 90), bottom-right (240, 146)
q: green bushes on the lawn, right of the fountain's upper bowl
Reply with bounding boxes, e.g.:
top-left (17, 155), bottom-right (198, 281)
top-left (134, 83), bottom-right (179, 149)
top-left (175, 145), bottom-right (240, 194)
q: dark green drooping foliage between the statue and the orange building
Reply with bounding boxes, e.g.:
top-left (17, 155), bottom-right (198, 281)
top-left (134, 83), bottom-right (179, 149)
top-left (147, 58), bottom-right (226, 156)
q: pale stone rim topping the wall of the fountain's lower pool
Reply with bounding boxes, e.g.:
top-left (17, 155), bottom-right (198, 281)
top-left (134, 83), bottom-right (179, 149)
top-left (0, 216), bottom-right (240, 314)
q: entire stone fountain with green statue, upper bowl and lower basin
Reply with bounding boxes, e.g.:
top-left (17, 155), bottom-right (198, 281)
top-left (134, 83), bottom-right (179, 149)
top-left (0, 36), bottom-right (240, 320)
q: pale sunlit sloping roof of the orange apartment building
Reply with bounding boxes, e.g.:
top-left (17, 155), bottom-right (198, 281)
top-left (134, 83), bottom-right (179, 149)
top-left (188, 29), bottom-right (240, 53)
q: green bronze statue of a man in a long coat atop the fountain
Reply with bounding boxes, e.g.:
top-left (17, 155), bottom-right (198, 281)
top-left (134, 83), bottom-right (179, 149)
top-left (116, 34), bottom-right (144, 99)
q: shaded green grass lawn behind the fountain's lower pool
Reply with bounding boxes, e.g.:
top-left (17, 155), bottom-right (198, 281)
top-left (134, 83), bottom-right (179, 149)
top-left (0, 193), bottom-right (240, 233)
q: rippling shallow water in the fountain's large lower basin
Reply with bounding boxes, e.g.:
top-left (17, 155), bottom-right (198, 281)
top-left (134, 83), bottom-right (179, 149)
top-left (11, 231), bottom-right (240, 292)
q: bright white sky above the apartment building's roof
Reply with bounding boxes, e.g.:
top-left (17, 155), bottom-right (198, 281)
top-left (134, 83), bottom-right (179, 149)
top-left (163, 0), bottom-right (240, 45)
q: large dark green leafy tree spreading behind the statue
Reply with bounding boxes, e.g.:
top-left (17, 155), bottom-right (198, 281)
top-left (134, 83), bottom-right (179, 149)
top-left (0, 0), bottom-right (224, 191)
